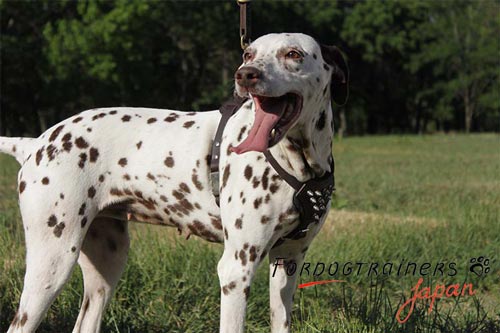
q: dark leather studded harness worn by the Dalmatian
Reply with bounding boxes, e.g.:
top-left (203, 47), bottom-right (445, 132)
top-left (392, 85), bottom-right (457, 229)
top-left (210, 96), bottom-right (335, 246)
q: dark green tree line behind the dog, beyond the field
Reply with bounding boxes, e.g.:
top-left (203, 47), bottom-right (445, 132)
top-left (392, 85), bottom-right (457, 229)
top-left (0, 0), bottom-right (500, 135)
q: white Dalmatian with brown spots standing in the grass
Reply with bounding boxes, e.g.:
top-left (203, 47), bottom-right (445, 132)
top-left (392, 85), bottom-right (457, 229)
top-left (0, 34), bottom-right (348, 333)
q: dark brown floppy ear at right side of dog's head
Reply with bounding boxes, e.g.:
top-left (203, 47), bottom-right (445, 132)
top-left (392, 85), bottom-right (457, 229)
top-left (320, 44), bottom-right (349, 105)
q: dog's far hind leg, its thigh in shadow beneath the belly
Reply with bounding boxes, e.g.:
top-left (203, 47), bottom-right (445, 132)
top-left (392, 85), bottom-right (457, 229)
top-left (73, 217), bottom-right (130, 333)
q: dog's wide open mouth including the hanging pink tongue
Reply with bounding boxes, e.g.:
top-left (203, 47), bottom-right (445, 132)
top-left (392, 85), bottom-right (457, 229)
top-left (231, 92), bottom-right (302, 154)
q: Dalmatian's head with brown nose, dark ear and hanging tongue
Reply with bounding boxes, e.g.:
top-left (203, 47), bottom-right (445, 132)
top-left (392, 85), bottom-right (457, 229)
top-left (234, 33), bottom-right (349, 153)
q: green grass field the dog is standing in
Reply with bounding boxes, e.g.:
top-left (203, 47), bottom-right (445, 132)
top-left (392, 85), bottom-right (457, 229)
top-left (0, 134), bottom-right (500, 333)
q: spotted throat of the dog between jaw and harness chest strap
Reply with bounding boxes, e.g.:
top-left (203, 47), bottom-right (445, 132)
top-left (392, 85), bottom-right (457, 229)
top-left (271, 93), bottom-right (333, 181)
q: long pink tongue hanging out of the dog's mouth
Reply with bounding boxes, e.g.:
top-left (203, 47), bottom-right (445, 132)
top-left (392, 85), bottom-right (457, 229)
top-left (230, 98), bottom-right (282, 154)
